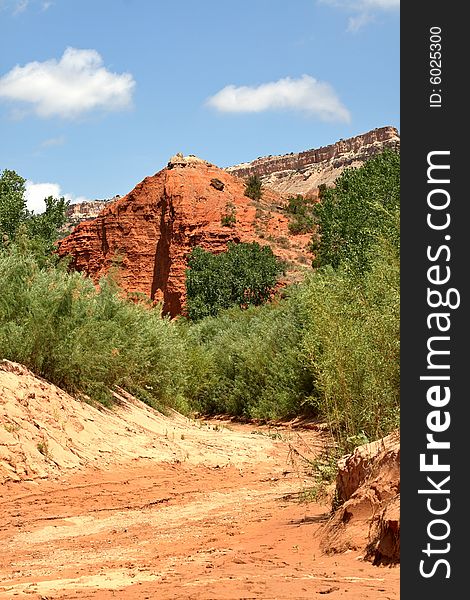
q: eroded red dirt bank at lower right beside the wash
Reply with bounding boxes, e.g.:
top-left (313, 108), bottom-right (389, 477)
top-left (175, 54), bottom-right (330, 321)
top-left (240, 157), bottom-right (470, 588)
top-left (322, 431), bottom-right (400, 564)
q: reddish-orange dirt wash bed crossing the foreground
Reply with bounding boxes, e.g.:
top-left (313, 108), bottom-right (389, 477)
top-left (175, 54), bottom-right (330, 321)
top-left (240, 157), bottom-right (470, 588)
top-left (0, 425), bottom-right (399, 600)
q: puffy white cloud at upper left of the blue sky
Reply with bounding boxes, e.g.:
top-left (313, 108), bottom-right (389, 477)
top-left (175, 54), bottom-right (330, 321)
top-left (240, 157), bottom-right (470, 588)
top-left (0, 48), bottom-right (135, 119)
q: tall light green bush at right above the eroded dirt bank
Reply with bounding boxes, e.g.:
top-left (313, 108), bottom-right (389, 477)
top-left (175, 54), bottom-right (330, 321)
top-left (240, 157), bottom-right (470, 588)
top-left (299, 241), bottom-right (400, 452)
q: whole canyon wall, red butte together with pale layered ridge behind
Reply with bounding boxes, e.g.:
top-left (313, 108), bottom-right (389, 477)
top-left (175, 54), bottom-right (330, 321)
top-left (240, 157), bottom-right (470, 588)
top-left (58, 127), bottom-right (400, 317)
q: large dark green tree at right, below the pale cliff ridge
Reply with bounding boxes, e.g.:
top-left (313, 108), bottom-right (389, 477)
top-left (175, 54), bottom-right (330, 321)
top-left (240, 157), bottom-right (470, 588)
top-left (312, 150), bottom-right (400, 273)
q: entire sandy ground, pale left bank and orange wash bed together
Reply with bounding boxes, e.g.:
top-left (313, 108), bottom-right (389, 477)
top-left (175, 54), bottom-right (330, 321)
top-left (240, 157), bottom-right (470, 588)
top-left (0, 369), bottom-right (399, 600)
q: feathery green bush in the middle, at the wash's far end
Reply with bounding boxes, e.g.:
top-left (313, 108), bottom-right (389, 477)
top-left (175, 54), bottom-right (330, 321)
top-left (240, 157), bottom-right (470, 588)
top-left (182, 302), bottom-right (312, 419)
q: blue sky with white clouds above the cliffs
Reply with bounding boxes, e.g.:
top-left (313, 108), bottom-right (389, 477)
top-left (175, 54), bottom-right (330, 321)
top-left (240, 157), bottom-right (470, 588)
top-left (0, 0), bottom-right (400, 212)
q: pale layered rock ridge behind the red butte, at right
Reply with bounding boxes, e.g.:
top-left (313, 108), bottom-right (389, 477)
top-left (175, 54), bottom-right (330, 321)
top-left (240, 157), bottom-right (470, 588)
top-left (227, 127), bottom-right (400, 197)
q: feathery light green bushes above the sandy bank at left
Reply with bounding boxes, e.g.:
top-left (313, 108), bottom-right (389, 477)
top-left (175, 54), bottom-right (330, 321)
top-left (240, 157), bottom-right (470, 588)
top-left (0, 247), bottom-right (185, 406)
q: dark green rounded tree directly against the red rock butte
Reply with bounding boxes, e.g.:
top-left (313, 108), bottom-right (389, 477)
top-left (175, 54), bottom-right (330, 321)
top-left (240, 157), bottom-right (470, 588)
top-left (186, 242), bottom-right (282, 321)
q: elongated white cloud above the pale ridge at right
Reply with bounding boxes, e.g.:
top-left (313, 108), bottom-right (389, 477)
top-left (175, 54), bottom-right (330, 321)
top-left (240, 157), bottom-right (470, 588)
top-left (207, 75), bottom-right (351, 122)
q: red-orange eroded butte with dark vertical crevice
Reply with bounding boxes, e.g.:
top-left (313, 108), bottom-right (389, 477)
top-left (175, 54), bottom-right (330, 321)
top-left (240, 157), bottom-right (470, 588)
top-left (58, 155), bottom-right (312, 316)
